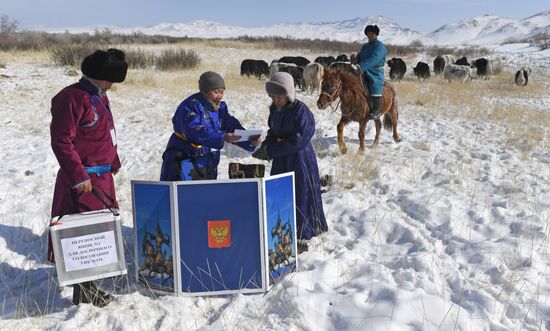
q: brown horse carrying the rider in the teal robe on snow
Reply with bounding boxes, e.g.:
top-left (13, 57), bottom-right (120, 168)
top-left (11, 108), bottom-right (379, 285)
top-left (317, 69), bottom-right (401, 154)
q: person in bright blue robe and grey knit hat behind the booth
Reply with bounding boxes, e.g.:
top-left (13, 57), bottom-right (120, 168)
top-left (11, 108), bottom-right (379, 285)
top-left (160, 71), bottom-right (260, 181)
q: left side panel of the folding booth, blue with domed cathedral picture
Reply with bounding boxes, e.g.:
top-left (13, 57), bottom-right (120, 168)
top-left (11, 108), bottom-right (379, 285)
top-left (133, 183), bottom-right (174, 291)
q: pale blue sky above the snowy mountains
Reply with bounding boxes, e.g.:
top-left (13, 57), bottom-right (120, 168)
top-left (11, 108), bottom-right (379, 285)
top-left (0, 0), bottom-right (550, 32)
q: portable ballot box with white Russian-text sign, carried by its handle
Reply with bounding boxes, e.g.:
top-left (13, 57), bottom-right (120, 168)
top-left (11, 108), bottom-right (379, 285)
top-left (50, 209), bottom-right (127, 286)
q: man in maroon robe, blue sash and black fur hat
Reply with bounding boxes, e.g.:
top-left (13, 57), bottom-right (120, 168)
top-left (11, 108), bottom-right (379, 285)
top-left (48, 49), bottom-right (128, 306)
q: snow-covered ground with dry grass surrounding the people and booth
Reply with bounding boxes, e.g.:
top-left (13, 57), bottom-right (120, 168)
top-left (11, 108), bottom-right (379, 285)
top-left (0, 45), bottom-right (550, 330)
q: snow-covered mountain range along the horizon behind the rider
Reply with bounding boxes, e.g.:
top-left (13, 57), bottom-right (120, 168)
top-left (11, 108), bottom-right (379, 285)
top-left (27, 10), bottom-right (550, 45)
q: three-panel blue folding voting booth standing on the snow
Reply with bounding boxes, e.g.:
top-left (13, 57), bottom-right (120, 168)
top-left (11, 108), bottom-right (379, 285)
top-left (132, 173), bottom-right (297, 295)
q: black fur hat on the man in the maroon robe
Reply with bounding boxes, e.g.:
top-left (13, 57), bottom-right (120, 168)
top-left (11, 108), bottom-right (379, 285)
top-left (80, 48), bottom-right (128, 83)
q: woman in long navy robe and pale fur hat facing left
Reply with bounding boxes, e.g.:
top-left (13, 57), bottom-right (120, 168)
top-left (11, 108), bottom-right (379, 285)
top-left (252, 72), bottom-right (328, 250)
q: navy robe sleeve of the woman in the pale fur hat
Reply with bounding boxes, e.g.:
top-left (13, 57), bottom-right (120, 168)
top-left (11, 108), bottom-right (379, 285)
top-left (267, 108), bottom-right (315, 159)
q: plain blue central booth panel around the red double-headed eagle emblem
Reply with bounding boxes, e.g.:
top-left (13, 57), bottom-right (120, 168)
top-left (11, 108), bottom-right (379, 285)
top-left (178, 182), bottom-right (262, 292)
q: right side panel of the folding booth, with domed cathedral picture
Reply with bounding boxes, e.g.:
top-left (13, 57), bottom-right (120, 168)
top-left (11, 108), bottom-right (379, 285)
top-left (265, 175), bottom-right (296, 284)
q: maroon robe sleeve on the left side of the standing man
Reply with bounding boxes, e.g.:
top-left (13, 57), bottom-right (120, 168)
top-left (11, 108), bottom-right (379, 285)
top-left (50, 93), bottom-right (90, 187)
